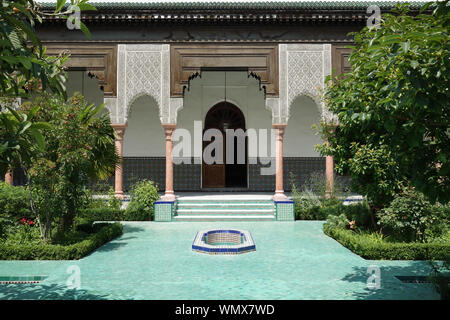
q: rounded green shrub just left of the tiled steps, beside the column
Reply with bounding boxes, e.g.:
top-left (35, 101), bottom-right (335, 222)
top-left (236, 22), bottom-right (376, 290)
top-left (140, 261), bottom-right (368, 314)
top-left (125, 180), bottom-right (159, 221)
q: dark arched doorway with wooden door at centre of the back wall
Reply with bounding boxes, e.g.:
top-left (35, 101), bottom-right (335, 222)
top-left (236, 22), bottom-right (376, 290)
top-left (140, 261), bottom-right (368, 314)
top-left (202, 101), bottom-right (247, 188)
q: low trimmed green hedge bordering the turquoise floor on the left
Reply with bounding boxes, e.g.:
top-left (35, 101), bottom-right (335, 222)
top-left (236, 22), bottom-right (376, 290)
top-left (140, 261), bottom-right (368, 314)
top-left (0, 223), bottom-right (122, 260)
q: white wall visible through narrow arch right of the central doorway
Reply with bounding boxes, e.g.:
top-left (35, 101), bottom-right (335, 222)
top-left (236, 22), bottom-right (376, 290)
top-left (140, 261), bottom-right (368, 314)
top-left (283, 96), bottom-right (322, 157)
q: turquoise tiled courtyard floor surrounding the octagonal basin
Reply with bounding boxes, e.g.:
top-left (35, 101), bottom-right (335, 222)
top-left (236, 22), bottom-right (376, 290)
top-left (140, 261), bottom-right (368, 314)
top-left (0, 221), bottom-right (439, 299)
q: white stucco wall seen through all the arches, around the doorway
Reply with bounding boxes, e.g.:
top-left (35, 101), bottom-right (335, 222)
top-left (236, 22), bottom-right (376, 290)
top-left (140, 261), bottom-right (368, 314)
top-left (67, 71), bottom-right (321, 157)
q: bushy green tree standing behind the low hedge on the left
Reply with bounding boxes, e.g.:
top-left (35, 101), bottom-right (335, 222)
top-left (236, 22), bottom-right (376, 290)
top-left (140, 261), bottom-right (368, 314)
top-left (22, 94), bottom-right (119, 239)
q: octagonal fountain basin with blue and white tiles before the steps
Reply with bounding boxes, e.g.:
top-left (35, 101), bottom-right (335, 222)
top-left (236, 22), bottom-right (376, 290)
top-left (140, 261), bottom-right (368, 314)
top-left (192, 229), bottom-right (256, 254)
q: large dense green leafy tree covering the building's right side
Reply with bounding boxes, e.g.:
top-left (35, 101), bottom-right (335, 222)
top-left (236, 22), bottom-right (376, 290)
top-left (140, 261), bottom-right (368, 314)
top-left (318, 1), bottom-right (450, 207)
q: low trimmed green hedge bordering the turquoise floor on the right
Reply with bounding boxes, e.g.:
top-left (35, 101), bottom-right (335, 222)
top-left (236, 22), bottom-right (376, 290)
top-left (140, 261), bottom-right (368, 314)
top-left (323, 224), bottom-right (450, 261)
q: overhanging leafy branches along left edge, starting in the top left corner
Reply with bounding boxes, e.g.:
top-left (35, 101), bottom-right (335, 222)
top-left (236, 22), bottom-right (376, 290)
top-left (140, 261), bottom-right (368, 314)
top-left (0, 0), bottom-right (96, 180)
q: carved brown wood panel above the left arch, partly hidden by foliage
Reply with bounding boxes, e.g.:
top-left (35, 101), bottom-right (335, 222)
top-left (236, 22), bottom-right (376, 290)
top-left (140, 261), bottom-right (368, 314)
top-left (44, 43), bottom-right (117, 97)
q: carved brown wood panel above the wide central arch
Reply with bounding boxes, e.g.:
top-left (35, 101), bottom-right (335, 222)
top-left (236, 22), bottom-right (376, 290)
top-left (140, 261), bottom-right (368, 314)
top-left (170, 44), bottom-right (279, 98)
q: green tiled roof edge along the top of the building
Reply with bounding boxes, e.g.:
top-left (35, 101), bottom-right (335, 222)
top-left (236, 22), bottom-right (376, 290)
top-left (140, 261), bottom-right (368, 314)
top-left (38, 0), bottom-right (427, 10)
